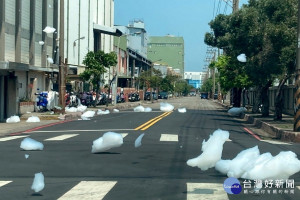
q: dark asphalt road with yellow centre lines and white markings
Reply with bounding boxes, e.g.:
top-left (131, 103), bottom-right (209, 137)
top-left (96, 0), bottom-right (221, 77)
top-left (0, 97), bottom-right (300, 200)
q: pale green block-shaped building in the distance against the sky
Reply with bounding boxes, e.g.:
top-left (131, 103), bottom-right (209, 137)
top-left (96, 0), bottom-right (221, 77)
top-left (147, 35), bottom-right (184, 77)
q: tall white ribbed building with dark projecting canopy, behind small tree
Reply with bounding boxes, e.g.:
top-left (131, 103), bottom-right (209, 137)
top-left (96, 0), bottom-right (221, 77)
top-left (64, 0), bottom-right (122, 90)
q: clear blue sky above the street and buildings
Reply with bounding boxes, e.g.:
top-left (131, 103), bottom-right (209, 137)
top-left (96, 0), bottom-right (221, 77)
top-left (115, 0), bottom-right (248, 71)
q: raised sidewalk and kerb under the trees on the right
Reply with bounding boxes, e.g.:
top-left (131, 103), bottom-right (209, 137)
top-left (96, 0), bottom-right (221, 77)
top-left (215, 101), bottom-right (300, 143)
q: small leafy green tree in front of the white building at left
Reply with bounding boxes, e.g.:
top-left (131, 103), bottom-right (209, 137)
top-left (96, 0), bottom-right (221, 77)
top-left (79, 51), bottom-right (117, 92)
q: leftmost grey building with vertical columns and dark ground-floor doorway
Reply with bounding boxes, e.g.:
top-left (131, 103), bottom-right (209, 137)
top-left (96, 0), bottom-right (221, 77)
top-left (0, 0), bottom-right (58, 121)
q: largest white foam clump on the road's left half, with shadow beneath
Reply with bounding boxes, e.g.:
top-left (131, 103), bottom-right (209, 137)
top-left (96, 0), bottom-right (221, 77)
top-left (92, 132), bottom-right (123, 153)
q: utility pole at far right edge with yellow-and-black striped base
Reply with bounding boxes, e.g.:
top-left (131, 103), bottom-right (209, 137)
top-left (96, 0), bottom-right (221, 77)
top-left (294, 0), bottom-right (300, 132)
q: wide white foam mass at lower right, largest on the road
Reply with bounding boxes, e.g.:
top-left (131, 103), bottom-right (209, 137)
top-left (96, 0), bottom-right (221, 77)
top-left (215, 146), bottom-right (300, 180)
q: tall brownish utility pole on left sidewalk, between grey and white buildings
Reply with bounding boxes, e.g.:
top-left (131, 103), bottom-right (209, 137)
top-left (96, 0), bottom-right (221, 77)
top-left (58, 0), bottom-right (66, 112)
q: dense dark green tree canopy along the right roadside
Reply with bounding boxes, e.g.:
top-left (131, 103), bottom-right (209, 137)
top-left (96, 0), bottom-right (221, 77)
top-left (205, 0), bottom-right (297, 89)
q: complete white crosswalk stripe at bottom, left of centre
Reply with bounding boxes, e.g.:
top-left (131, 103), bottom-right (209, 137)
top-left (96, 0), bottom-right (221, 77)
top-left (59, 181), bottom-right (117, 200)
